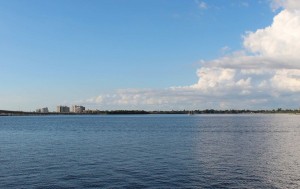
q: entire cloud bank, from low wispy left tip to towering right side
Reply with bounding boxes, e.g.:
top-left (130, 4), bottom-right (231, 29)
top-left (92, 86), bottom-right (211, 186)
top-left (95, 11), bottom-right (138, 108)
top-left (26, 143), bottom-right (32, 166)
top-left (82, 0), bottom-right (300, 110)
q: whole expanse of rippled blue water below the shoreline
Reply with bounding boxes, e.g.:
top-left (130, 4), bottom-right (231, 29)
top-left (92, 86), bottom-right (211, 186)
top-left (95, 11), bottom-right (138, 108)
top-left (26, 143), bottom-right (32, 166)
top-left (0, 115), bottom-right (300, 189)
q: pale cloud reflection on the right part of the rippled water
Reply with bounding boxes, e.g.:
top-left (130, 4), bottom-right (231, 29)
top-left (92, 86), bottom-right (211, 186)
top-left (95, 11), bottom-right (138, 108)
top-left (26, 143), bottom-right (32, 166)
top-left (190, 115), bottom-right (300, 188)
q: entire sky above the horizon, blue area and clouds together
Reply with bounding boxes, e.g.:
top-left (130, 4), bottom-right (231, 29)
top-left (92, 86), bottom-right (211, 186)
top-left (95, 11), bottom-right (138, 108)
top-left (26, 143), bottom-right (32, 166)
top-left (0, 0), bottom-right (300, 111)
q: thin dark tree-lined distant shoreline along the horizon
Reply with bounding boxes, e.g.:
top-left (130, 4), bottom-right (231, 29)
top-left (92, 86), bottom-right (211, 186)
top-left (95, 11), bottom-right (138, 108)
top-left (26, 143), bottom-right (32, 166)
top-left (0, 108), bottom-right (300, 116)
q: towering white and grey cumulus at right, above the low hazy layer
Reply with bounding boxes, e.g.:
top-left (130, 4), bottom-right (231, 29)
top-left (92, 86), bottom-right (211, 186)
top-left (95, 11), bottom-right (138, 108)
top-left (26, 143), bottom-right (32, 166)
top-left (192, 0), bottom-right (300, 94)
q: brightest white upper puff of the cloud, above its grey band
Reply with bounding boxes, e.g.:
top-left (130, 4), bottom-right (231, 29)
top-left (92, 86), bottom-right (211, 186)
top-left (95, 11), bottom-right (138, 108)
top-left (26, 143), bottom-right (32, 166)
top-left (244, 9), bottom-right (300, 61)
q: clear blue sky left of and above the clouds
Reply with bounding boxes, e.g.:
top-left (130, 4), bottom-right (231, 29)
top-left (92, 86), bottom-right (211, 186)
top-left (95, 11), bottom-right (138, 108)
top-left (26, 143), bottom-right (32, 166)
top-left (0, 0), bottom-right (298, 110)
